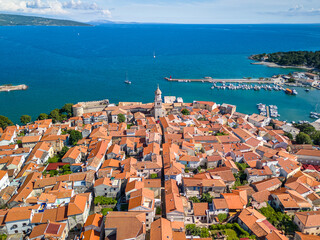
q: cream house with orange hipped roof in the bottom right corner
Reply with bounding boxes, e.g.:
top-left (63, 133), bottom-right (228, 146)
top-left (293, 211), bottom-right (320, 235)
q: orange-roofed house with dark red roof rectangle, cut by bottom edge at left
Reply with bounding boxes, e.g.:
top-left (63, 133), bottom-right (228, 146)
top-left (29, 221), bottom-right (68, 240)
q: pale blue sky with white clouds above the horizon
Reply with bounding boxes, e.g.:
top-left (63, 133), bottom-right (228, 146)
top-left (0, 0), bottom-right (320, 24)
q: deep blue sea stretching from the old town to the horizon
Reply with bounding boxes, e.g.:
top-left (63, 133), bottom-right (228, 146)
top-left (0, 24), bottom-right (320, 123)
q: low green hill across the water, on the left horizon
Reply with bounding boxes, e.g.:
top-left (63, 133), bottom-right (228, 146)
top-left (0, 14), bottom-right (91, 26)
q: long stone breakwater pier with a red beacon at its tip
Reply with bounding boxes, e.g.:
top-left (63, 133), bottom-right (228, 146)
top-left (164, 77), bottom-right (273, 84)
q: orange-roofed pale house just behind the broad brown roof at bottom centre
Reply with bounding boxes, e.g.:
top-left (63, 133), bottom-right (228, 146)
top-left (128, 188), bottom-right (155, 229)
